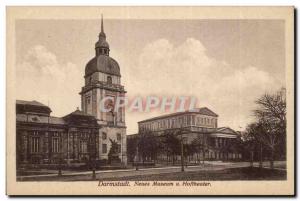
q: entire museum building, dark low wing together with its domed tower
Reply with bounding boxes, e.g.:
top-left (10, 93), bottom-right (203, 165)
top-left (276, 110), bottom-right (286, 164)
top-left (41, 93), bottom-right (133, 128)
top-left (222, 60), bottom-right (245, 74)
top-left (16, 16), bottom-right (127, 166)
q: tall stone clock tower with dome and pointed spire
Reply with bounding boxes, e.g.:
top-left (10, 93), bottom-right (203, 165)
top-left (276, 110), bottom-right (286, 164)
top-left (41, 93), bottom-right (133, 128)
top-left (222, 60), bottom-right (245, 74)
top-left (80, 17), bottom-right (127, 164)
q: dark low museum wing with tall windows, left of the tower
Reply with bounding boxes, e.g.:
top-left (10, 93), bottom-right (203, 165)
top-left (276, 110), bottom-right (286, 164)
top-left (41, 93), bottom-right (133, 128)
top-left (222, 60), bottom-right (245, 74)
top-left (16, 100), bottom-right (100, 165)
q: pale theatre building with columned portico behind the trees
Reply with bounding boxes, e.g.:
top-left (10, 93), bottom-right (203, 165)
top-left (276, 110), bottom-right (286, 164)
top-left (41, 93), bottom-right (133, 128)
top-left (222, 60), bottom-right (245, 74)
top-left (128, 107), bottom-right (242, 160)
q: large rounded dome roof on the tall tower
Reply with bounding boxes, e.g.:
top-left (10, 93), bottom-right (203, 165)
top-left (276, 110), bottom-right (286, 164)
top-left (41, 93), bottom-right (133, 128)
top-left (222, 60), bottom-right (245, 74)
top-left (85, 54), bottom-right (121, 76)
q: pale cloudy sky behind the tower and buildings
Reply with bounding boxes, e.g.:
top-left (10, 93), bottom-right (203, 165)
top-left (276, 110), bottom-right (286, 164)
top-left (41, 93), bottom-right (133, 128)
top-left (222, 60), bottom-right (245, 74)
top-left (16, 19), bottom-right (286, 134)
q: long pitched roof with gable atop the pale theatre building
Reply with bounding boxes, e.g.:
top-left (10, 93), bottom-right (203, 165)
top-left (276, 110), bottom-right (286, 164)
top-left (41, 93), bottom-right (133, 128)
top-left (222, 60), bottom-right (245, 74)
top-left (138, 107), bottom-right (218, 123)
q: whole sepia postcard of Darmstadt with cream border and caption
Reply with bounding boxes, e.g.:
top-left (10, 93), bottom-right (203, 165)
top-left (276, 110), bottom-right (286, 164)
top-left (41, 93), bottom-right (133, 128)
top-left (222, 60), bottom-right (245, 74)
top-left (6, 6), bottom-right (295, 195)
